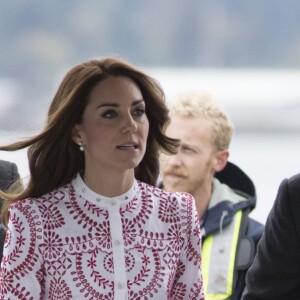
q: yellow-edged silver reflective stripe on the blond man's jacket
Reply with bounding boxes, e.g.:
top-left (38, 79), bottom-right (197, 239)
top-left (202, 211), bottom-right (242, 300)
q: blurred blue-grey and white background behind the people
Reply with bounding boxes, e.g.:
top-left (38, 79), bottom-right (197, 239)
top-left (0, 0), bottom-right (300, 222)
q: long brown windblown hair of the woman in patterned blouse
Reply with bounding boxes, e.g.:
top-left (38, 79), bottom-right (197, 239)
top-left (0, 57), bottom-right (179, 224)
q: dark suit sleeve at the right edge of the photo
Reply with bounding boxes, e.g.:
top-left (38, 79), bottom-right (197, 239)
top-left (242, 175), bottom-right (300, 300)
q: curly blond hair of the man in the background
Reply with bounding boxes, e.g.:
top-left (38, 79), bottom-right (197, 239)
top-left (168, 92), bottom-right (234, 150)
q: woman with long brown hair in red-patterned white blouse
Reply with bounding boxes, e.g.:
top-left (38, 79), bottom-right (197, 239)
top-left (0, 58), bottom-right (204, 300)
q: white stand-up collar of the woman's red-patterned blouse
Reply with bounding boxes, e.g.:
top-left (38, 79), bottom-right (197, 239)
top-left (72, 174), bottom-right (138, 207)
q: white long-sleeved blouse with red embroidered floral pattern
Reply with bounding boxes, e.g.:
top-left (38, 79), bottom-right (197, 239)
top-left (0, 175), bottom-right (204, 300)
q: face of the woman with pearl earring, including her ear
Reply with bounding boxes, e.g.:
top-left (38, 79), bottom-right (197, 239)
top-left (73, 76), bottom-right (149, 174)
